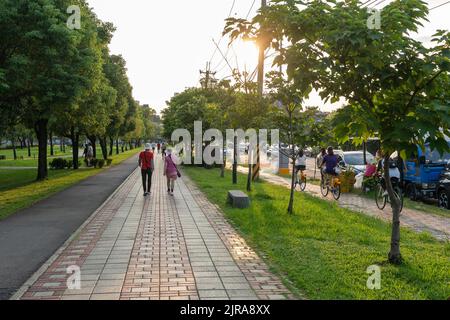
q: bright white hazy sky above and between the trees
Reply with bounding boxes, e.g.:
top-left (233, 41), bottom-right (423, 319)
top-left (88, 0), bottom-right (450, 112)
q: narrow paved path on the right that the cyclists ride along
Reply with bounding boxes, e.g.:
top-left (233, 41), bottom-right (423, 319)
top-left (244, 167), bottom-right (450, 241)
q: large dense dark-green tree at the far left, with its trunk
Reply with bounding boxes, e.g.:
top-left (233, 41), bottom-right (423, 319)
top-left (0, 0), bottom-right (107, 180)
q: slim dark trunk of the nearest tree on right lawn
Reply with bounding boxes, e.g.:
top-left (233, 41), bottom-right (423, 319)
top-left (384, 155), bottom-right (402, 264)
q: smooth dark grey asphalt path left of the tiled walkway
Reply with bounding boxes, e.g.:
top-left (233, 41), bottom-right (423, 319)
top-left (0, 156), bottom-right (137, 300)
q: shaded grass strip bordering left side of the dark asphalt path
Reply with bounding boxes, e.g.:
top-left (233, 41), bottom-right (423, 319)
top-left (0, 149), bottom-right (140, 220)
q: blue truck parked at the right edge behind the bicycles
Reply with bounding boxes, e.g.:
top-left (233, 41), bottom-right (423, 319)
top-left (404, 138), bottom-right (450, 209)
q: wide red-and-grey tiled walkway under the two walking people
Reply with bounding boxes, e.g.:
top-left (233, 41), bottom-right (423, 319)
top-left (13, 160), bottom-right (294, 300)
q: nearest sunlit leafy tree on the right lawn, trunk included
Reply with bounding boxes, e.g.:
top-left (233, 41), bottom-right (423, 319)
top-left (228, 0), bottom-right (450, 263)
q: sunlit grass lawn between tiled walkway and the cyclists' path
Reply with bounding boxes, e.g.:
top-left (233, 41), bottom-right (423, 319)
top-left (183, 167), bottom-right (450, 299)
